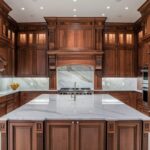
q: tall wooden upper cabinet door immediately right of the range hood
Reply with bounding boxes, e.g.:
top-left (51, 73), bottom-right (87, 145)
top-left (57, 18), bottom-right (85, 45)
top-left (104, 50), bottom-right (117, 77)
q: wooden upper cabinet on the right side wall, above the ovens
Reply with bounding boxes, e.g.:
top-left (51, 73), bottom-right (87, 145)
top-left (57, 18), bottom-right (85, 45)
top-left (137, 0), bottom-right (150, 71)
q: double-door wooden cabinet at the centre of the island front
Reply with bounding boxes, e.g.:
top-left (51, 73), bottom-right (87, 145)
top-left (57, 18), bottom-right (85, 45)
top-left (45, 121), bottom-right (105, 150)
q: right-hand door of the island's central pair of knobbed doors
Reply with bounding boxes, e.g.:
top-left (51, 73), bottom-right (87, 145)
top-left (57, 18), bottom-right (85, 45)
top-left (75, 121), bottom-right (106, 150)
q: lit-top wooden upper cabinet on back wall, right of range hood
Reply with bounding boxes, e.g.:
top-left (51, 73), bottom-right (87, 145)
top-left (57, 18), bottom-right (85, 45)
top-left (103, 23), bottom-right (136, 77)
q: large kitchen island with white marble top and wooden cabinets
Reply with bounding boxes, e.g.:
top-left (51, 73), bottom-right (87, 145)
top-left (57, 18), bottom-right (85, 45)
top-left (0, 94), bottom-right (150, 150)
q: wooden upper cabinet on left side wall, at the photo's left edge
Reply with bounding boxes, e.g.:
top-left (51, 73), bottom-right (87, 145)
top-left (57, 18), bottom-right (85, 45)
top-left (0, 1), bottom-right (17, 76)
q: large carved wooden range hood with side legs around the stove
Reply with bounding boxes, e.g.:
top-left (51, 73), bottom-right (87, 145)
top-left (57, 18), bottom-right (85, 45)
top-left (45, 17), bottom-right (106, 89)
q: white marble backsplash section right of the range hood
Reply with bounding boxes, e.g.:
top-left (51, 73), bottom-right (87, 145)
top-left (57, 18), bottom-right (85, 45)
top-left (102, 78), bottom-right (137, 91)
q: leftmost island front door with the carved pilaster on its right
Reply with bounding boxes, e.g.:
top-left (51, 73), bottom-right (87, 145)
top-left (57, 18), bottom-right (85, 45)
top-left (8, 121), bottom-right (43, 150)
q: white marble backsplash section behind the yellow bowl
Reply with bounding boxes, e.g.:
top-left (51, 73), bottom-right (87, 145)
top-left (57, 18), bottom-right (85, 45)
top-left (0, 78), bottom-right (49, 91)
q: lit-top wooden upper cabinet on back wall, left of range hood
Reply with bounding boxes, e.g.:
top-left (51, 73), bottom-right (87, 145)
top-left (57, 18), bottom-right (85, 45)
top-left (17, 23), bottom-right (47, 77)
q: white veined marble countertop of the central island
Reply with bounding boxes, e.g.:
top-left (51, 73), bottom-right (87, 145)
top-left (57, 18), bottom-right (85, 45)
top-left (0, 94), bottom-right (150, 120)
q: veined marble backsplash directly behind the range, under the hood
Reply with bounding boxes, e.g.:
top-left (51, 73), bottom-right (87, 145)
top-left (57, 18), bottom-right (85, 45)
top-left (57, 65), bottom-right (94, 89)
